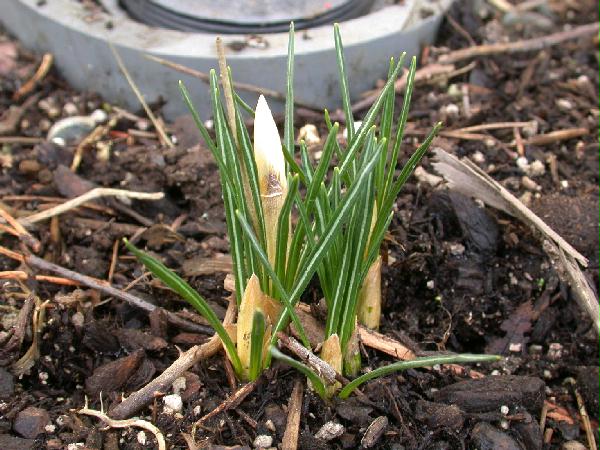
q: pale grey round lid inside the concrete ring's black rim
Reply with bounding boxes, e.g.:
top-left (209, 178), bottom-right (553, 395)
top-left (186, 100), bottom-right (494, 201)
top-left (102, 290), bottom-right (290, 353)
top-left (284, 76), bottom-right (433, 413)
top-left (121, 0), bottom-right (372, 34)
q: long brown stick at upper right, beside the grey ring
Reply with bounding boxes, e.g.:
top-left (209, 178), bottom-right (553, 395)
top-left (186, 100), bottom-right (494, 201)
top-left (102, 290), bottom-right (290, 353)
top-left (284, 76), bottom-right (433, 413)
top-left (439, 22), bottom-right (600, 64)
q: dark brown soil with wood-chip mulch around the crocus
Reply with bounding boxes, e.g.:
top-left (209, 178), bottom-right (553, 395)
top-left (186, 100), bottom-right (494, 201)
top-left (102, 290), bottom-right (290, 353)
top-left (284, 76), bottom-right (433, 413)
top-left (0, 0), bottom-right (600, 449)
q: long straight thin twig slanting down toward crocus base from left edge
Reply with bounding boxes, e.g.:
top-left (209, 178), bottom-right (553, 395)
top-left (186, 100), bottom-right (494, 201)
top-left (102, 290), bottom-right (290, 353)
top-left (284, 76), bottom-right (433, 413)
top-left (24, 255), bottom-right (212, 334)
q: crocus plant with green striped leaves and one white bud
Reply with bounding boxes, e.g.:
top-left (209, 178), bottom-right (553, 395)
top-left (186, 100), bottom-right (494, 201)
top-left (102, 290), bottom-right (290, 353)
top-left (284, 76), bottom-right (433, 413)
top-left (126, 25), bottom-right (496, 397)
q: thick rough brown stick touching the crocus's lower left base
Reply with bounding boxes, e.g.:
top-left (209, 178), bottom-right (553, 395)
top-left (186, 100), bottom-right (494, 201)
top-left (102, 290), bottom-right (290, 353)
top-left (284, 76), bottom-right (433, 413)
top-left (110, 298), bottom-right (236, 419)
